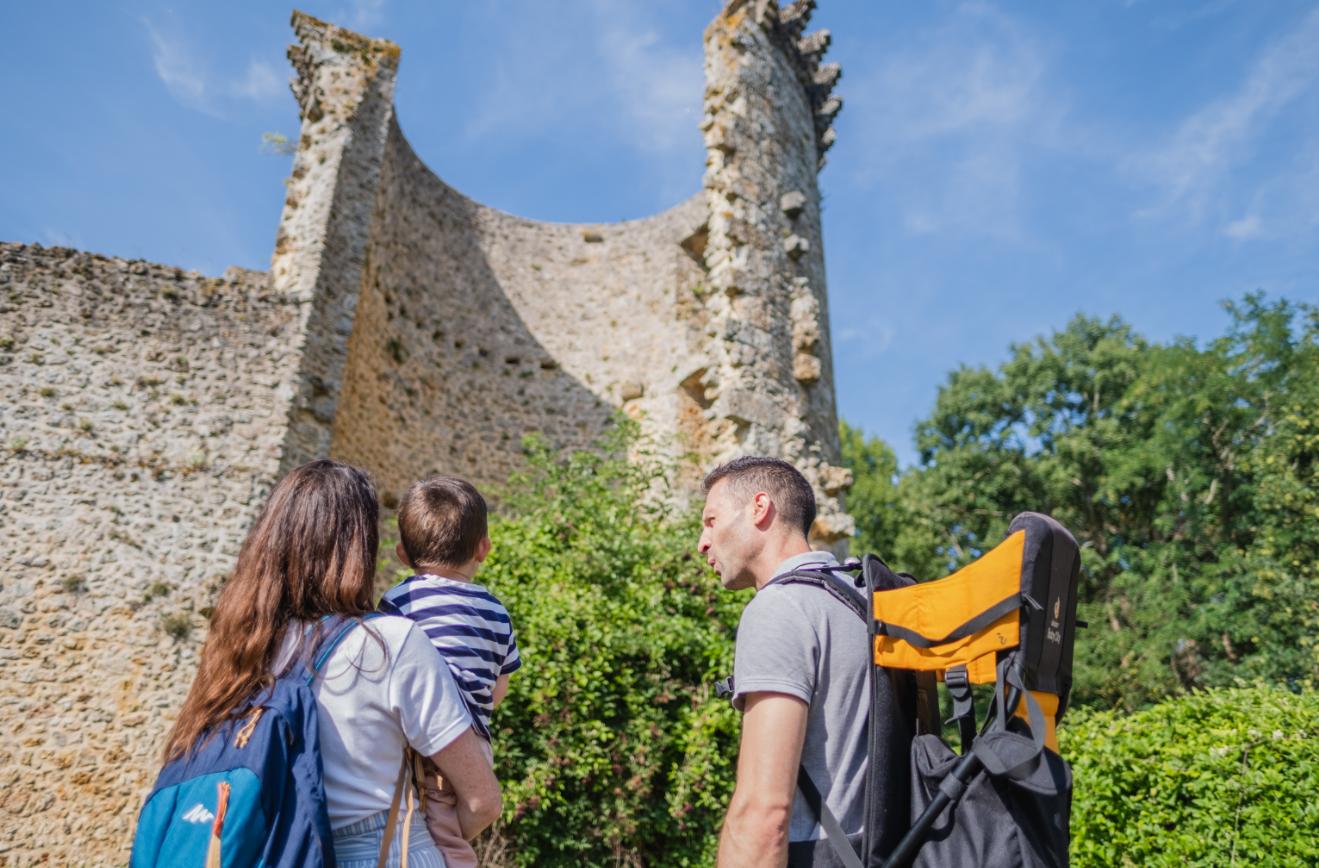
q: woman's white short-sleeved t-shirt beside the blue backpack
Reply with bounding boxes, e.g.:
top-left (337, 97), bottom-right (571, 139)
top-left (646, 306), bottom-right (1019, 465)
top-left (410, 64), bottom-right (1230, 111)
top-left (274, 616), bottom-right (472, 828)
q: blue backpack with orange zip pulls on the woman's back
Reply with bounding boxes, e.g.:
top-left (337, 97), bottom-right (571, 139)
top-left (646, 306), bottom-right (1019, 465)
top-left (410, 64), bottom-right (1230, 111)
top-left (129, 612), bottom-right (379, 868)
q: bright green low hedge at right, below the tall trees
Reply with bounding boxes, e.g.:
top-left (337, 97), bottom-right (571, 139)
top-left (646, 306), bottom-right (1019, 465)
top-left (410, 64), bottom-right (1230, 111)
top-left (1058, 687), bottom-right (1319, 868)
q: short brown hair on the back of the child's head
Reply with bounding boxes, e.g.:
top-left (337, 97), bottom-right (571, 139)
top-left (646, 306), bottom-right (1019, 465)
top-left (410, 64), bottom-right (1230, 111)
top-left (398, 476), bottom-right (489, 570)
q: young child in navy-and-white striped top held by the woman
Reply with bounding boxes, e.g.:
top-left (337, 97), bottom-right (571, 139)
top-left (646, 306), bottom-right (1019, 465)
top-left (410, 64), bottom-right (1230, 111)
top-left (379, 476), bottom-right (522, 868)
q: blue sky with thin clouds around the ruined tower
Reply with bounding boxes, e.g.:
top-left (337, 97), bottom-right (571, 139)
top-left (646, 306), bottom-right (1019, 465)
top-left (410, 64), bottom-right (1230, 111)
top-left (0, 0), bottom-right (1319, 460)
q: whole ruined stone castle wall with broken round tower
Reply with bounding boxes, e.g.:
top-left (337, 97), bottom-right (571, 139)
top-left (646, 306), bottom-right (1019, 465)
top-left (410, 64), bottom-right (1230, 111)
top-left (0, 0), bottom-right (851, 867)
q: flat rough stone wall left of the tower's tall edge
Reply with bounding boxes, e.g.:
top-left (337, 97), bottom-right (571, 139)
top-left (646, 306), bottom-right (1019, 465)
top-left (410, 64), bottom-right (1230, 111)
top-left (0, 244), bottom-right (303, 865)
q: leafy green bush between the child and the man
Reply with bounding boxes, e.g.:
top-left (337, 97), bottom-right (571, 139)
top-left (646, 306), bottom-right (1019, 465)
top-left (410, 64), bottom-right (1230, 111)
top-left (479, 422), bottom-right (748, 867)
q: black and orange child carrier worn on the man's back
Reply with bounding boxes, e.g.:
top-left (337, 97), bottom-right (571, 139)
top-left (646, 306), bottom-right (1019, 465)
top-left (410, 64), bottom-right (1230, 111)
top-left (720, 512), bottom-right (1084, 868)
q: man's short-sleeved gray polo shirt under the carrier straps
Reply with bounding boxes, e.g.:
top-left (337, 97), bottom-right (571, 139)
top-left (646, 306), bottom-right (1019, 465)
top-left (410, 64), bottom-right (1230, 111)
top-left (733, 551), bottom-right (871, 840)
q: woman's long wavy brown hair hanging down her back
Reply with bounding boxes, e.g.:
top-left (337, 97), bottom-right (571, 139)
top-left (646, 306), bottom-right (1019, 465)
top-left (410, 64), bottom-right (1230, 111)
top-left (164, 459), bottom-right (380, 762)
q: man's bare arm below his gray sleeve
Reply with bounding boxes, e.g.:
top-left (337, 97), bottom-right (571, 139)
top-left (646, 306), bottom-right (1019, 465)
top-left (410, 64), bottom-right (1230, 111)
top-left (718, 693), bottom-right (809, 868)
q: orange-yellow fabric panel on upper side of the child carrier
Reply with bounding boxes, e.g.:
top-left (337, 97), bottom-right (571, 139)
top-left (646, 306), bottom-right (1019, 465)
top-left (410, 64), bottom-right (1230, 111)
top-left (874, 530), bottom-right (1026, 670)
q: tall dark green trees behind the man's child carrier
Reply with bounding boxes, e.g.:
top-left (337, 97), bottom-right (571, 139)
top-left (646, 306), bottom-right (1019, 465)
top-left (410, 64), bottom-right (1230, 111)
top-left (844, 295), bottom-right (1319, 710)
